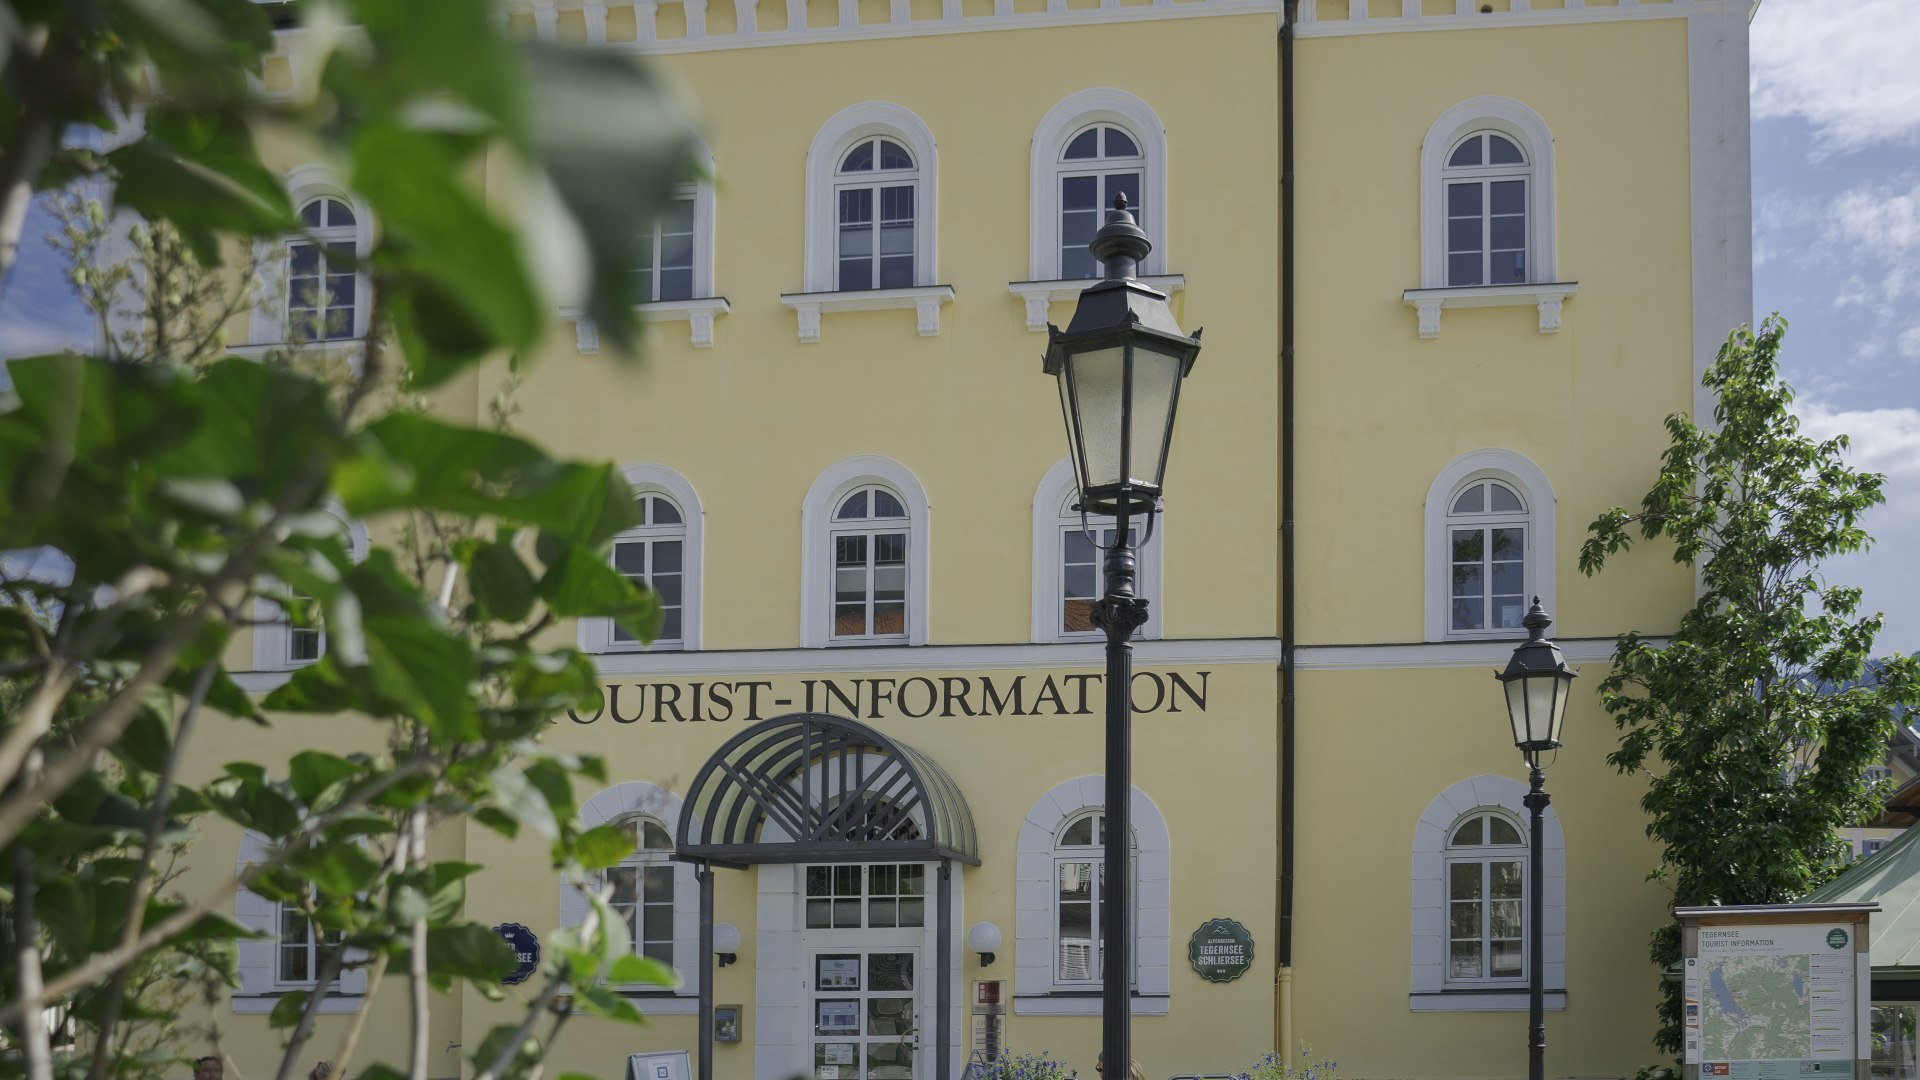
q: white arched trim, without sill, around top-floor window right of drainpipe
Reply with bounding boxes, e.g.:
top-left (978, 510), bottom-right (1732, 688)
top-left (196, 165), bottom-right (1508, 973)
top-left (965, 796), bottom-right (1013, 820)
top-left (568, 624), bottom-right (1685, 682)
top-left (1421, 96), bottom-right (1559, 290)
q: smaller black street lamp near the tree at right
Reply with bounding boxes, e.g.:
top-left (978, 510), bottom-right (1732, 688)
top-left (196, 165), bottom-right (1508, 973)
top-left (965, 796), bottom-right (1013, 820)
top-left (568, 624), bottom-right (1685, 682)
top-left (1494, 596), bottom-right (1578, 1080)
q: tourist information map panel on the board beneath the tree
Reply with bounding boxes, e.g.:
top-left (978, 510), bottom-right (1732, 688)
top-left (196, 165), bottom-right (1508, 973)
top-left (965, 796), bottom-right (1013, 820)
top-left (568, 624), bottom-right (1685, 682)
top-left (1684, 922), bottom-right (1859, 1080)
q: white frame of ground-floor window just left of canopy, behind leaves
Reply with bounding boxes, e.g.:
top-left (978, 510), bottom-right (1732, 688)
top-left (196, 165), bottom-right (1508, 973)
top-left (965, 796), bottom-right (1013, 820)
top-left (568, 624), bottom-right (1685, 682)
top-left (561, 780), bottom-right (701, 1017)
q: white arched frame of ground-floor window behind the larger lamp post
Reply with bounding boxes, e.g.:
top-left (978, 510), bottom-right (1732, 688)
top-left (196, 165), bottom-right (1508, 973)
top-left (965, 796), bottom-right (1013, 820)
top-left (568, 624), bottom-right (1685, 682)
top-left (1014, 776), bottom-right (1173, 1017)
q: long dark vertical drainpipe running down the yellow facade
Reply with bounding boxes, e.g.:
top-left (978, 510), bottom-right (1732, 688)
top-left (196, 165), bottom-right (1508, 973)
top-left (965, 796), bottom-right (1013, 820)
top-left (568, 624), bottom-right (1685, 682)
top-left (1275, 0), bottom-right (1300, 1068)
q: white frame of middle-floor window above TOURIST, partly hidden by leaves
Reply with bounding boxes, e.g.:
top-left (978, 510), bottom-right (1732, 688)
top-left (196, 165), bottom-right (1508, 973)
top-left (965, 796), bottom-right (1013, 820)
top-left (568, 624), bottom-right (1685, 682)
top-left (580, 463), bottom-right (707, 653)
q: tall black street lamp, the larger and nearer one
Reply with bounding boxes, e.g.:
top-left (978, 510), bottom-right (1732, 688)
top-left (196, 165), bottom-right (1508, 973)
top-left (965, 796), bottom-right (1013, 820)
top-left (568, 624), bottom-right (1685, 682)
top-left (1044, 194), bottom-right (1200, 1078)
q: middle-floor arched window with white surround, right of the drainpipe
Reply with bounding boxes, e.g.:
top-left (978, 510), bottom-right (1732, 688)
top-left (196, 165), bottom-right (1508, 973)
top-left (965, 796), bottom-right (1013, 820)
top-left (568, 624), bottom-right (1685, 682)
top-left (1427, 448), bottom-right (1557, 642)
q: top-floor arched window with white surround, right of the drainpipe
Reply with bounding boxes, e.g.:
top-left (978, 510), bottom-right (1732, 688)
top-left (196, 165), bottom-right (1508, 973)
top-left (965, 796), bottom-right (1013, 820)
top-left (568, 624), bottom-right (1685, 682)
top-left (1421, 96), bottom-right (1559, 288)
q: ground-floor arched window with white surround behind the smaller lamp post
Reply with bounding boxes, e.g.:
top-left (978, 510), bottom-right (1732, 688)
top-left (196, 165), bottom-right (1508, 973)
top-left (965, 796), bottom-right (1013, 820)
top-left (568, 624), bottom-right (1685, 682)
top-left (1409, 774), bottom-right (1567, 1011)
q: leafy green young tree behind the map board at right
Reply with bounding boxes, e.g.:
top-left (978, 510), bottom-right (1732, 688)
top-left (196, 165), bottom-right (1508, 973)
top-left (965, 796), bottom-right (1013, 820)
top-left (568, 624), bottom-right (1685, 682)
top-left (1580, 315), bottom-right (1920, 1051)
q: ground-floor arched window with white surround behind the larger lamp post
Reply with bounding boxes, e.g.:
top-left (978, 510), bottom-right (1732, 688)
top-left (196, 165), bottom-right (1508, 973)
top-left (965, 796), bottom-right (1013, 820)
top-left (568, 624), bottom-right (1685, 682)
top-left (1014, 776), bottom-right (1173, 1017)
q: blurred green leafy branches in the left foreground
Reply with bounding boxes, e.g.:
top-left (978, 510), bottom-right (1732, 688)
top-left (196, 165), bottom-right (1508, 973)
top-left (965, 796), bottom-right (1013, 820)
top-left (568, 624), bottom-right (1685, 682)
top-left (0, 0), bottom-right (693, 1080)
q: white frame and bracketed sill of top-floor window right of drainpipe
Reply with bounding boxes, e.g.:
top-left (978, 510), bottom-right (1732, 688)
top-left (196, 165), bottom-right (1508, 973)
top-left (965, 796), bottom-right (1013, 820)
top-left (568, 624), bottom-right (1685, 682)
top-left (1404, 96), bottom-right (1578, 338)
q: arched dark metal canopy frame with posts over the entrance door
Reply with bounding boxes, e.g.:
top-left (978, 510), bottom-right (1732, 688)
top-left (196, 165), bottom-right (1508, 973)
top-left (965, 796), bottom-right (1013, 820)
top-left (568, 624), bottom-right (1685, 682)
top-left (674, 713), bottom-right (979, 1080)
